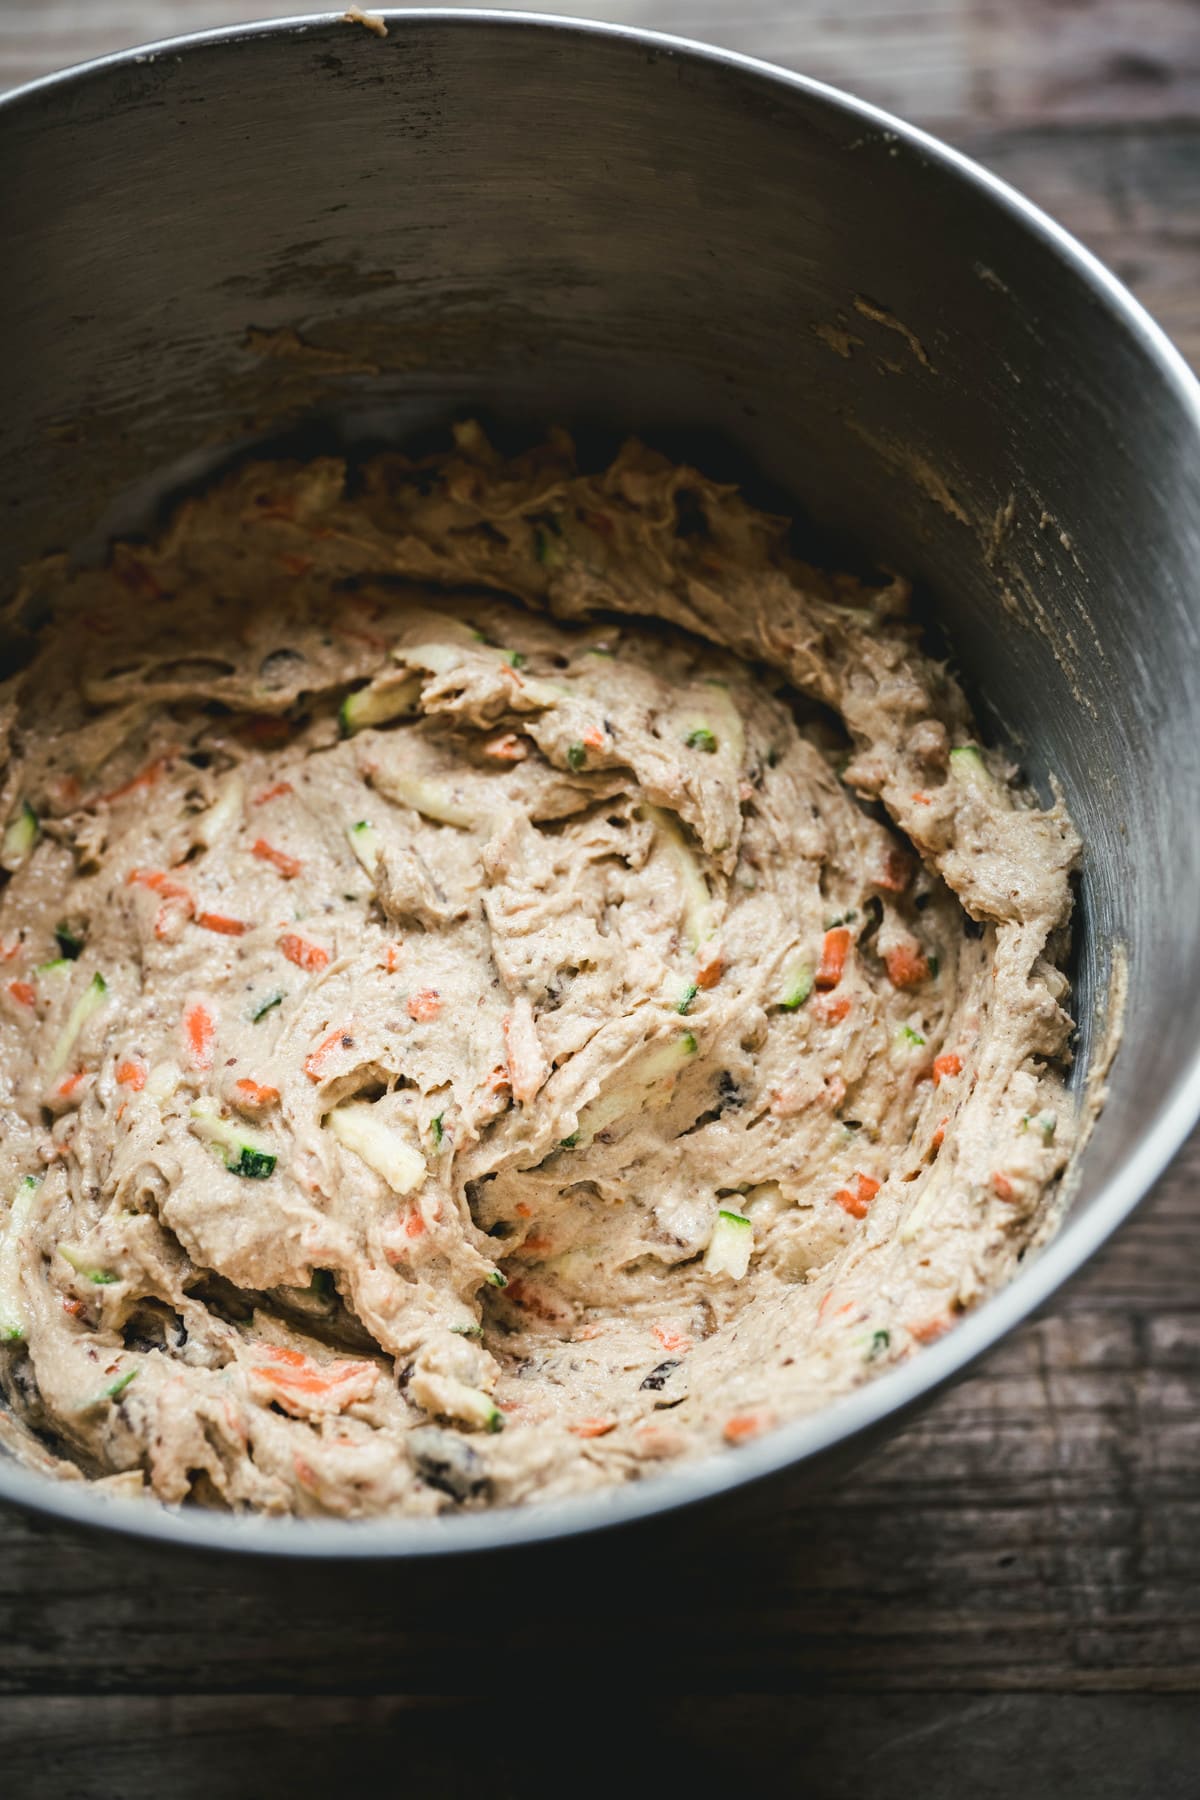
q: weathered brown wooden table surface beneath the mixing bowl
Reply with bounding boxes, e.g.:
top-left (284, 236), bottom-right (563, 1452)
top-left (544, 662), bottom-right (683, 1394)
top-left (0, 0), bottom-right (1200, 1800)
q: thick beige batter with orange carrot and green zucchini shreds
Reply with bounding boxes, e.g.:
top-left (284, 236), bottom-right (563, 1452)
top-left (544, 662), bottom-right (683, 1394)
top-left (0, 425), bottom-right (1078, 1516)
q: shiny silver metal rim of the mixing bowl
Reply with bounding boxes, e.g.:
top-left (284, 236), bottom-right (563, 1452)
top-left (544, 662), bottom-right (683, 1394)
top-left (0, 7), bottom-right (1200, 1561)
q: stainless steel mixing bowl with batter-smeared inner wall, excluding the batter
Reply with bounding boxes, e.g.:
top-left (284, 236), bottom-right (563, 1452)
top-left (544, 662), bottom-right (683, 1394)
top-left (0, 13), bottom-right (1200, 1557)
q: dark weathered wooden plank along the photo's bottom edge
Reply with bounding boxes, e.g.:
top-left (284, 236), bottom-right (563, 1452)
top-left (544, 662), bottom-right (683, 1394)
top-left (0, 1692), bottom-right (1200, 1800)
